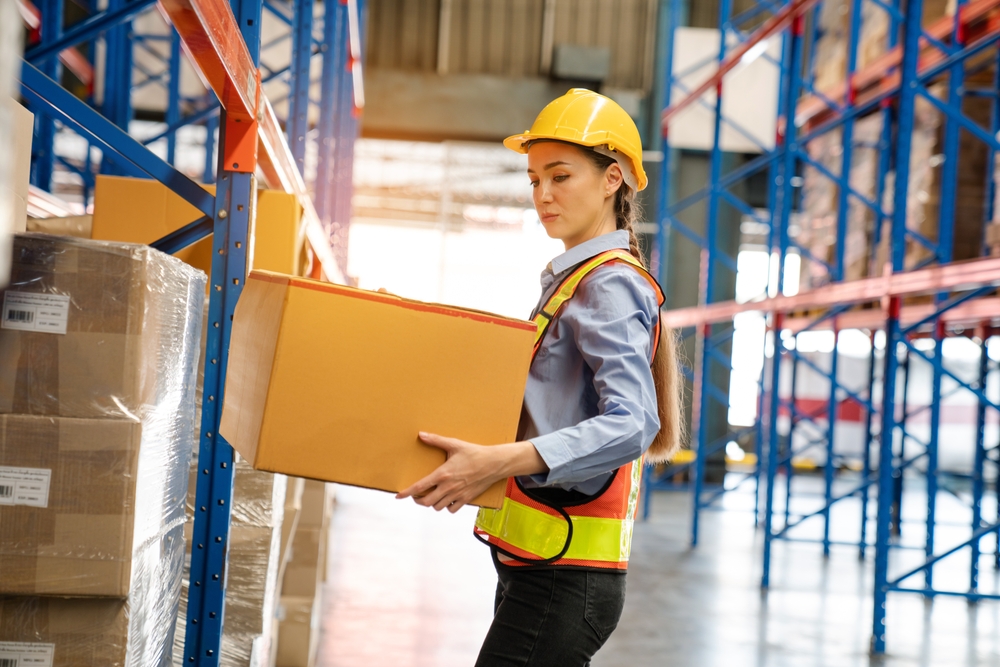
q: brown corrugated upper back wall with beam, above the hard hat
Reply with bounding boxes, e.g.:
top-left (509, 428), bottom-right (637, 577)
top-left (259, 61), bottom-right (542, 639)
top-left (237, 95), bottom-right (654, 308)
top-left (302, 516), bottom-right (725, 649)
top-left (362, 0), bottom-right (658, 141)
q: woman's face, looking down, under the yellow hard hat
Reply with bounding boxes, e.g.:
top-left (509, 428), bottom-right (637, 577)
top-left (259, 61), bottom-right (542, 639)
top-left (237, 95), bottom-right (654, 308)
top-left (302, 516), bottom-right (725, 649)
top-left (528, 141), bottom-right (622, 250)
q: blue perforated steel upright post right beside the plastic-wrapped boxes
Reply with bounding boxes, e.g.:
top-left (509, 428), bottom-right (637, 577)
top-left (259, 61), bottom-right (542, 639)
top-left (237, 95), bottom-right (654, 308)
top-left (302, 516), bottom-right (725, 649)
top-left (184, 0), bottom-right (262, 667)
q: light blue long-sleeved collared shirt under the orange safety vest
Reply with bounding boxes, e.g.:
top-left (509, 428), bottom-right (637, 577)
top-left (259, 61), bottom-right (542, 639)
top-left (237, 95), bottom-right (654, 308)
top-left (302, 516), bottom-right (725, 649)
top-left (520, 231), bottom-right (660, 495)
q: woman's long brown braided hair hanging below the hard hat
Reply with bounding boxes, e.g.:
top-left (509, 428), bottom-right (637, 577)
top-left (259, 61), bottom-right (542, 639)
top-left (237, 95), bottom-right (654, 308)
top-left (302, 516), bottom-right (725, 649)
top-left (570, 144), bottom-right (684, 463)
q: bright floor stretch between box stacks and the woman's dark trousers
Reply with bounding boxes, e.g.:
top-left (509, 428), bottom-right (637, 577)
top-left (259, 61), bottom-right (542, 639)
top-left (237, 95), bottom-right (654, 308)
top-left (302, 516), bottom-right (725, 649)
top-left (317, 486), bottom-right (496, 667)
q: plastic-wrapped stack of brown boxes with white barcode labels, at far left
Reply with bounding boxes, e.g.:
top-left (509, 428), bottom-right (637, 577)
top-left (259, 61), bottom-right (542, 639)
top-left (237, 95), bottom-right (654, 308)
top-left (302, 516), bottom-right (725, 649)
top-left (0, 234), bottom-right (205, 667)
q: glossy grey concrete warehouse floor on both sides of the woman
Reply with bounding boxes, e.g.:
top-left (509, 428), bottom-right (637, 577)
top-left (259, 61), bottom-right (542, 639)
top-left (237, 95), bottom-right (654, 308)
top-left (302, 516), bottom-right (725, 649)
top-left (319, 487), bottom-right (1000, 667)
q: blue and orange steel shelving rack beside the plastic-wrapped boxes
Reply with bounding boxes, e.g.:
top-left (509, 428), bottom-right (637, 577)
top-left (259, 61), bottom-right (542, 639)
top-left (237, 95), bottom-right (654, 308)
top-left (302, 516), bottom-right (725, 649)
top-left (18, 0), bottom-right (364, 666)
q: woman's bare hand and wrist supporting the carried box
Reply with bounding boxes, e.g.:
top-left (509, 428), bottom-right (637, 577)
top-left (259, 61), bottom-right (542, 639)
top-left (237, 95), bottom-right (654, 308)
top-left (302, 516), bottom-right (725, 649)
top-left (396, 433), bottom-right (548, 513)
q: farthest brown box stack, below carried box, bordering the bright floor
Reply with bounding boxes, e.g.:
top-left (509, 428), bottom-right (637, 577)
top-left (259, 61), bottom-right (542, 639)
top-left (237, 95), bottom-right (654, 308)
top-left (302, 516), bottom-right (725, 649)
top-left (275, 480), bottom-right (333, 667)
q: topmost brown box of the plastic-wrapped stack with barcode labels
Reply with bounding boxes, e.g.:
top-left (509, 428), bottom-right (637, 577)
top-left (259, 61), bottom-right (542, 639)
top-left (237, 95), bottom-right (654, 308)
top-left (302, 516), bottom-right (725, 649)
top-left (0, 234), bottom-right (206, 420)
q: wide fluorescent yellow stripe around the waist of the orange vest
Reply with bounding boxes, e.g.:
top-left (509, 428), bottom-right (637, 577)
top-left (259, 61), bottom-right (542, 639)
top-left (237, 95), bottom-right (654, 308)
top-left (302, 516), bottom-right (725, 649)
top-left (476, 498), bottom-right (632, 563)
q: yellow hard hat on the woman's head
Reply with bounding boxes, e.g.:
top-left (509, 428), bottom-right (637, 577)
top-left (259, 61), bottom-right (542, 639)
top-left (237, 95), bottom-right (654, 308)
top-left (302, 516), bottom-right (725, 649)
top-left (503, 88), bottom-right (647, 191)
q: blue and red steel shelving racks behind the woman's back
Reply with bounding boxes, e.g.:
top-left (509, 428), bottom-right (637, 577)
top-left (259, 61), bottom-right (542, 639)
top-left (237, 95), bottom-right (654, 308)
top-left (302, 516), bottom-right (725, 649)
top-left (654, 0), bottom-right (1000, 653)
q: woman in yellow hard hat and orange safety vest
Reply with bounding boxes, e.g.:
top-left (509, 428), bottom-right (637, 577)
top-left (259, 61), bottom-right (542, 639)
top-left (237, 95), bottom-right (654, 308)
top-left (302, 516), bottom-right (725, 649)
top-left (397, 89), bottom-right (680, 667)
